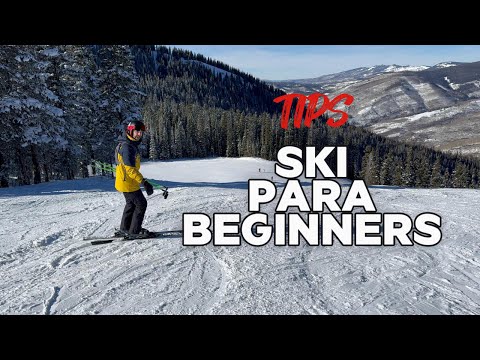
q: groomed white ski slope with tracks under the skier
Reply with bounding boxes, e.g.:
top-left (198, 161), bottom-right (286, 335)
top-left (0, 158), bottom-right (480, 314)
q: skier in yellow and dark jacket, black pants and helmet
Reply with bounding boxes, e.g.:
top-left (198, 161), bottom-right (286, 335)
top-left (115, 120), bottom-right (153, 237)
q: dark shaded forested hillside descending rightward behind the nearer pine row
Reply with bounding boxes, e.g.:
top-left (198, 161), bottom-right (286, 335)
top-left (132, 45), bottom-right (283, 114)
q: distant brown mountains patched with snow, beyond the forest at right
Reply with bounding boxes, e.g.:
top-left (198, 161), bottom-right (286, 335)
top-left (268, 62), bottom-right (480, 156)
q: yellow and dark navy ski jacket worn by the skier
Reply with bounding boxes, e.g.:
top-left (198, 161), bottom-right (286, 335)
top-left (115, 135), bottom-right (143, 192)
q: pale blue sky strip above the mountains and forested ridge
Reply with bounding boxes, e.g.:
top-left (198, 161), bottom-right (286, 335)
top-left (167, 45), bottom-right (480, 80)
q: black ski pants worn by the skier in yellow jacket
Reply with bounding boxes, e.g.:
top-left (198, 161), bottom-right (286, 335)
top-left (120, 190), bottom-right (147, 234)
